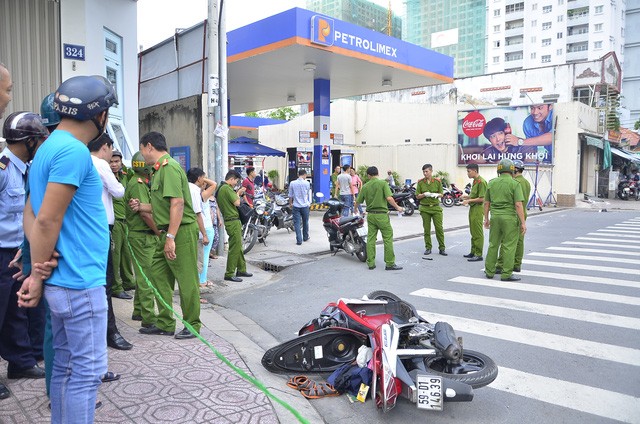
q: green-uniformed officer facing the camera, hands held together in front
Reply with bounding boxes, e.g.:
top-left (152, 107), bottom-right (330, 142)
top-left (416, 163), bottom-right (447, 256)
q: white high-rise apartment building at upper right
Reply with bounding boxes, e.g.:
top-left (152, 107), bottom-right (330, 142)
top-left (485, 0), bottom-right (626, 73)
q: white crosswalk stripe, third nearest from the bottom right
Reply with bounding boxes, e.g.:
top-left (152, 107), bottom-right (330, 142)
top-left (411, 289), bottom-right (640, 330)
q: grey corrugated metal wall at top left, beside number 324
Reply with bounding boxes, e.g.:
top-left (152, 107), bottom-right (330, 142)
top-left (0, 0), bottom-right (59, 117)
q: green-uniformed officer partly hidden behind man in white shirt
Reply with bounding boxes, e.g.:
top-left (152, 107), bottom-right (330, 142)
top-left (109, 150), bottom-right (135, 299)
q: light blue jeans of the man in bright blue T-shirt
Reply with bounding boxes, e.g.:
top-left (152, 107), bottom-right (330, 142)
top-left (44, 285), bottom-right (107, 424)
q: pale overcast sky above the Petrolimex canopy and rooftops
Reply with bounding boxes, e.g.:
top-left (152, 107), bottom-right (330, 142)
top-left (138, 0), bottom-right (401, 49)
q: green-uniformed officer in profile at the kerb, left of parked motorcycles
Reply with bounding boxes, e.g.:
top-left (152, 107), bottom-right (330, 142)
top-left (216, 170), bottom-right (253, 283)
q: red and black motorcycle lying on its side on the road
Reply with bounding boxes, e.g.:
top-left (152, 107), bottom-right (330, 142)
top-left (262, 291), bottom-right (498, 412)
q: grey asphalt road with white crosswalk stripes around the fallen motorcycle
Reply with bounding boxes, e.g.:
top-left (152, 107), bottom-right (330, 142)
top-left (216, 209), bottom-right (640, 423)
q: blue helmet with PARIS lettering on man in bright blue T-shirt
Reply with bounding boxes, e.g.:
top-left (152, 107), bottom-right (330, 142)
top-left (53, 75), bottom-right (118, 121)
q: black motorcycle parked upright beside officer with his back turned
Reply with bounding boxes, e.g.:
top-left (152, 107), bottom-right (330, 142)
top-left (316, 193), bottom-right (367, 262)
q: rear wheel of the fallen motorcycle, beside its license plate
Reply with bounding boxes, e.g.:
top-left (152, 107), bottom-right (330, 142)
top-left (424, 350), bottom-right (498, 389)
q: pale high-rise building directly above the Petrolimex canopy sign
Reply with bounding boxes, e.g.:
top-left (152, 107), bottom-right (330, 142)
top-left (306, 0), bottom-right (402, 39)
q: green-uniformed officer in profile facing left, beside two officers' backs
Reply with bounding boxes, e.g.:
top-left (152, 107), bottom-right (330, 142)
top-left (462, 163), bottom-right (487, 262)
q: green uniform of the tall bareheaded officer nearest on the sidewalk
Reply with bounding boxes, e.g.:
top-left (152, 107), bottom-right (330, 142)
top-left (150, 154), bottom-right (202, 332)
